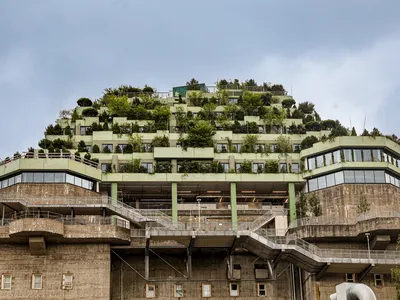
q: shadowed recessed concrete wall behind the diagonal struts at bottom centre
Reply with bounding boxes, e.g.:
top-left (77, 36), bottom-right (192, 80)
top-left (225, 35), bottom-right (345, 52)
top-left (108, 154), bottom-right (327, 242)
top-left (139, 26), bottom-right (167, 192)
top-left (111, 250), bottom-right (290, 300)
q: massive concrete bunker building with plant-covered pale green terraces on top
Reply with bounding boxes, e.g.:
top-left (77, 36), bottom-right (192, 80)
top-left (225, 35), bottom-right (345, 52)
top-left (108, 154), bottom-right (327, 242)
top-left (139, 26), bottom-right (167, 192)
top-left (0, 82), bottom-right (400, 300)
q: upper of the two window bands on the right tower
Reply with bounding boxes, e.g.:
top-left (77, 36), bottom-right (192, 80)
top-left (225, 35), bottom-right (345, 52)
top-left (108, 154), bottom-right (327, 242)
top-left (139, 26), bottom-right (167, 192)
top-left (307, 149), bottom-right (400, 170)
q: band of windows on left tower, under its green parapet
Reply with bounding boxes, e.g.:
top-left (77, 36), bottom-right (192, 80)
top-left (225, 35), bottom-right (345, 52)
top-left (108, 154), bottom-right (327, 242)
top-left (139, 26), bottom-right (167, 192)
top-left (0, 172), bottom-right (95, 190)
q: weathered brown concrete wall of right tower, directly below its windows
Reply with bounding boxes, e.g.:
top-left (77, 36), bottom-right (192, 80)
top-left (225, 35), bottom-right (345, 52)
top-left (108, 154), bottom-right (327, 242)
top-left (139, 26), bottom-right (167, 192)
top-left (310, 184), bottom-right (400, 219)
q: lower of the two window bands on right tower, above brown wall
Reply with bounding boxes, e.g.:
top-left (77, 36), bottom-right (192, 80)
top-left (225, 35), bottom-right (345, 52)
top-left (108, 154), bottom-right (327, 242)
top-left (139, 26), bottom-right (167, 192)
top-left (307, 170), bottom-right (400, 192)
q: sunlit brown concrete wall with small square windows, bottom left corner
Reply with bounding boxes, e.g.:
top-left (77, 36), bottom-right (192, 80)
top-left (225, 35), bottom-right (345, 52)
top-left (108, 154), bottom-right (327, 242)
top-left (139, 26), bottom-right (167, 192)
top-left (0, 244), bottom-right (110, 300)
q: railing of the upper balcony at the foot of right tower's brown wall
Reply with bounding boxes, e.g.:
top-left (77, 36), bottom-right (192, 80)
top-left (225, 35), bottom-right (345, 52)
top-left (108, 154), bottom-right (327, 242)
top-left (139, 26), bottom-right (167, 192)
top-left (289, 207), bottom-right (400, 228)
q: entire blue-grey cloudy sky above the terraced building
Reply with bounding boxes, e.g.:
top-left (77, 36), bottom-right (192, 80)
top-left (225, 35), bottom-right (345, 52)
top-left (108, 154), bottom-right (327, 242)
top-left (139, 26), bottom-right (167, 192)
top-left (0, 0), bottom-right (400, 159)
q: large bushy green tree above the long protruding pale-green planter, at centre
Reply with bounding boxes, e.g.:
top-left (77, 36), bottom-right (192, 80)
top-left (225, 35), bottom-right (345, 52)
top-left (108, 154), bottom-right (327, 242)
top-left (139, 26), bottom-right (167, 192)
top-left (186, 120), bottom-right (215, 148)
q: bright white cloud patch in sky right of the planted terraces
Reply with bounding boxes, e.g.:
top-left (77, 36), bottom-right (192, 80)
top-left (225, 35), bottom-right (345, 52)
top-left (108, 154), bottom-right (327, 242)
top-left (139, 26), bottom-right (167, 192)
top-left (253, 37), bottom-right (400, 133)
